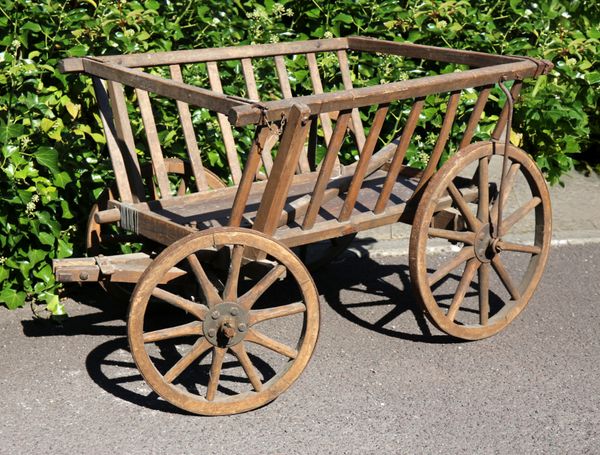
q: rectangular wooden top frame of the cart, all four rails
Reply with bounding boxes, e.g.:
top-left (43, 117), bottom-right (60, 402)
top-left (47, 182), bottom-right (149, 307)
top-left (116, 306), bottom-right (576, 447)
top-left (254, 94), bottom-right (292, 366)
top-left (60, 36), bottom-right (552, 126)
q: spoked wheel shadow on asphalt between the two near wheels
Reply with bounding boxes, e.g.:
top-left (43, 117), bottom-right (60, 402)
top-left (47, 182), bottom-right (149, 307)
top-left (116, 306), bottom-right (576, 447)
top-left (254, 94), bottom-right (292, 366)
top-left (313, 244), bottom-right (465, 344)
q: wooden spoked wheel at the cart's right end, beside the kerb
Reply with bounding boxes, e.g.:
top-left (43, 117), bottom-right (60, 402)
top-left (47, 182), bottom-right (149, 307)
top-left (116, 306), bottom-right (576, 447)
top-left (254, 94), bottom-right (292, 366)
top-left (409, 142), bottom-right (552, 340)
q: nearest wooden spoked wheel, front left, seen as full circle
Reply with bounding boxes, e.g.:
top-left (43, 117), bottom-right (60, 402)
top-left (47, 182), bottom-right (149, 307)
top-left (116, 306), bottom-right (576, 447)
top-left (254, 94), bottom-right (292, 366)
top-left (128, 228), bottom-right (319, 415)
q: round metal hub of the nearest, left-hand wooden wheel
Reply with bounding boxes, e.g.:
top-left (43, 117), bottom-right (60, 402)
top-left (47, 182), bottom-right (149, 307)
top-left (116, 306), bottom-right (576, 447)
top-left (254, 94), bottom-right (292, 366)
top-left (202, 302), bottom-right (248, 347)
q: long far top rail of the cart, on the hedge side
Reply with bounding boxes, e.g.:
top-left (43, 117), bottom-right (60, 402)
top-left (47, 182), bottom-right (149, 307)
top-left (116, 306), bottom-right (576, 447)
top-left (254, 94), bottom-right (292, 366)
top-left (59, 38), bottom-right (348, 73)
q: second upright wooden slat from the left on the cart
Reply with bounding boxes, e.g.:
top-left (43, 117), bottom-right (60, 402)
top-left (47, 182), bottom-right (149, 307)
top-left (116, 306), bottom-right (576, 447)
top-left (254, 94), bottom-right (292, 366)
top-left (108, 81), bottom-right (146, 202)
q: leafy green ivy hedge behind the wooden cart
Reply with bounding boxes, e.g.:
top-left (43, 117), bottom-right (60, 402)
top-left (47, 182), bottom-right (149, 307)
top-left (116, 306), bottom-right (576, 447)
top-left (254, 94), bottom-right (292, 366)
top-left (0, 0), bottom-right (600, 315)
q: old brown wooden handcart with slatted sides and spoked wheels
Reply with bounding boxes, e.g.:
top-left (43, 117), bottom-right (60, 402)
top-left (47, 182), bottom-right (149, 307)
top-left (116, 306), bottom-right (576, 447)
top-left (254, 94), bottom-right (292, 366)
top-left (54, 37), bottom-right (552, 414)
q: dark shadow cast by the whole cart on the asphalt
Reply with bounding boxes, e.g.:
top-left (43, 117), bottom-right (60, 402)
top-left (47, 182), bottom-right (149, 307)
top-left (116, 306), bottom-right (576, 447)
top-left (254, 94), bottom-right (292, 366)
top-left (22, 244), bottom-right (474, 414)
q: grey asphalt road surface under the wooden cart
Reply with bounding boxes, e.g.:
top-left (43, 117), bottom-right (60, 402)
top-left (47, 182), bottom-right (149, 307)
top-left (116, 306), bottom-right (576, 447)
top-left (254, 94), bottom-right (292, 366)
top-left (0, 244), bottom-right (600, 454)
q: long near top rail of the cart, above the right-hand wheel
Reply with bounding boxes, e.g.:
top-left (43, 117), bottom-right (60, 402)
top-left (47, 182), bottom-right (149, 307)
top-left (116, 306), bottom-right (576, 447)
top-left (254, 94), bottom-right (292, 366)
top-left (229, 60), bottom-right (537, 126)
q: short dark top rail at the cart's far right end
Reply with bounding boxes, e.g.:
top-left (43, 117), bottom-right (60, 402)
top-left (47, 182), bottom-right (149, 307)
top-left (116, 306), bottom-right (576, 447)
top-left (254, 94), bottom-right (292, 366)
top-left (348, 36), bottom-right (522, 67)
